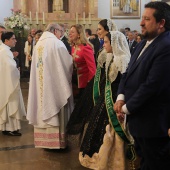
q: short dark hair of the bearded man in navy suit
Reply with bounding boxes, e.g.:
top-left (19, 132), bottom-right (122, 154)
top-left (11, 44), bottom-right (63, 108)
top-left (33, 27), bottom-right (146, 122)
top-left (145, 1), bottom-right (170, 30)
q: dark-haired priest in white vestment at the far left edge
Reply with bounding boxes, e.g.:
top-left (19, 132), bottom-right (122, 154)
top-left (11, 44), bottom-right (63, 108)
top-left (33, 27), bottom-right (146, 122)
top-left (0, 32), bottom-right (26, 136)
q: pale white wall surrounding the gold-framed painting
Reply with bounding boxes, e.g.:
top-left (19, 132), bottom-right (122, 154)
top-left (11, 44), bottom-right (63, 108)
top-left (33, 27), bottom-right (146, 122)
top-left (98, 0), bottom-right (150, 31)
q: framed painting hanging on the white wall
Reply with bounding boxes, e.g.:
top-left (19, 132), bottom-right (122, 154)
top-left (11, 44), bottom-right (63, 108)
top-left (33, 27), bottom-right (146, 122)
top-left (110, 0), bottom-right (141, 19)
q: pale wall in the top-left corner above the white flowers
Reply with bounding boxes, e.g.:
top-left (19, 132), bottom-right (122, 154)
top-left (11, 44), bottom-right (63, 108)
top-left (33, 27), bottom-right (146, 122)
top-left (0, 0), bottom-right (13, 24)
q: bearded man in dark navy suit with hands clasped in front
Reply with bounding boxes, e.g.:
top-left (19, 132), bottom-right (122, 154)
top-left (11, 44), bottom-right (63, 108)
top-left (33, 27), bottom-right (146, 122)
top-left (114, 1), bottom-right (170, 170)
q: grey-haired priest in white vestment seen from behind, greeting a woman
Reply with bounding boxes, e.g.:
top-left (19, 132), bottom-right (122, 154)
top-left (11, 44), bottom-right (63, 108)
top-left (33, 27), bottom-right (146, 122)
top-left (27, 24), bottom-right (74, 149)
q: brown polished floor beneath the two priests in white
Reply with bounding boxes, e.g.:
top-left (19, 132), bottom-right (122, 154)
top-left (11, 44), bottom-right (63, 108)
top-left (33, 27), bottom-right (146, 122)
top-left (0, 82), bottom-right (86, 170)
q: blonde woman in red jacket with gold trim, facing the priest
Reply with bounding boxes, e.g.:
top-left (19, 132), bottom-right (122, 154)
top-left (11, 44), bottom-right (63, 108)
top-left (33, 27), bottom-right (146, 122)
top-left (69, 24), bottom-right (96, 98)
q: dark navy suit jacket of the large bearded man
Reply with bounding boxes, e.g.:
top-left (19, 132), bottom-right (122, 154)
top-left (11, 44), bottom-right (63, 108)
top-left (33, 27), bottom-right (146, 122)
top-left (118, 31), bottom-right (170, 137)
